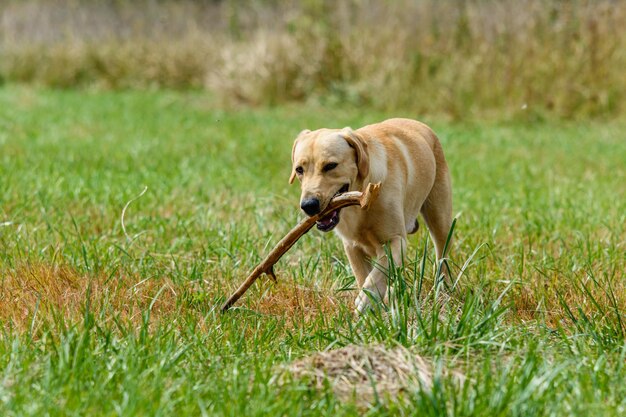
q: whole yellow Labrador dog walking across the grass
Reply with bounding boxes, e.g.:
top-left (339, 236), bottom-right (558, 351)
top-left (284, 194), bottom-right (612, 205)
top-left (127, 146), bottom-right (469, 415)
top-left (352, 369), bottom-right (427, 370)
top-left (289, 118), bottom-right (452, 313)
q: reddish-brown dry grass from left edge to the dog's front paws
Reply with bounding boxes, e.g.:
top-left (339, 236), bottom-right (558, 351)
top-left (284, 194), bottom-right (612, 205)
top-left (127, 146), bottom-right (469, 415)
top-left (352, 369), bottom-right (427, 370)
top-left (0, 262), bottom-right (346, 334)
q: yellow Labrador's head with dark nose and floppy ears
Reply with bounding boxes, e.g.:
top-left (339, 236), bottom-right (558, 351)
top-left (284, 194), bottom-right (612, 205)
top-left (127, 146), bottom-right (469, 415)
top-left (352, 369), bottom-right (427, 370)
top-left (289, 127), bottom-right (369, 232)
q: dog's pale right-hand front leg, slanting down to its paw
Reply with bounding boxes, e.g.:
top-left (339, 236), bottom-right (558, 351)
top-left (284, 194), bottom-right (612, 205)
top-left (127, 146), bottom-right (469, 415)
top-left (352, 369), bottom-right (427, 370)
top-left (355, 236), bottom-right (406, 314)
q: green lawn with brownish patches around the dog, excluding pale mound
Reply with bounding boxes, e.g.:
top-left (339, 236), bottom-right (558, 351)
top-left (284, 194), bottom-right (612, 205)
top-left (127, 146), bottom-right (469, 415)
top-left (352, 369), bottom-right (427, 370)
top-left (0, 86), bottom-right (626, 416)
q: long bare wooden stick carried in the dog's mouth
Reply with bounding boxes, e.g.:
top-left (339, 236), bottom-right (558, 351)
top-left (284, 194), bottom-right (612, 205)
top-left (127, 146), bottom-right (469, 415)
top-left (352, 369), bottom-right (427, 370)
top-left (222, 183), bottom-right (380, 312)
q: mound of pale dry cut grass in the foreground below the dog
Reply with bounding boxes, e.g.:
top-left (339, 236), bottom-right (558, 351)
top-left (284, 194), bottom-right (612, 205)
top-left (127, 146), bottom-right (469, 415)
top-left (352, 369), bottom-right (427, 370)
top-left (279, 345), bottom-right (465, 404)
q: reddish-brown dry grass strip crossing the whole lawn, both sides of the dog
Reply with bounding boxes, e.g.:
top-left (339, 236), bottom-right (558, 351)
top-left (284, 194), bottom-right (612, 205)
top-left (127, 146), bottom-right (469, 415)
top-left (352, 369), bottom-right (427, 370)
top-left (0, 254), bottom-right (626, 334)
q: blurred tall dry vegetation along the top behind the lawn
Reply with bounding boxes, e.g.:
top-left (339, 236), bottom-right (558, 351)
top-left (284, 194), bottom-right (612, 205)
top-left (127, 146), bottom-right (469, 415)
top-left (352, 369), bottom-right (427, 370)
top-left (0, 0), bottom-right (626, 119)
